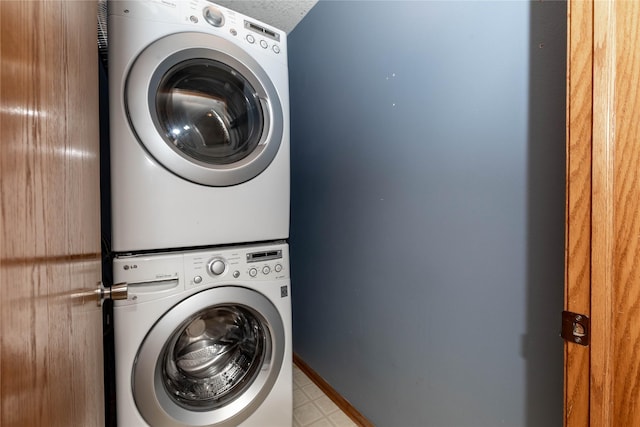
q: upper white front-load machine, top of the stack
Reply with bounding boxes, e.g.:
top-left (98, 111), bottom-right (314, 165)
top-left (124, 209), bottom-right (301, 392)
top-left (108, 0), bottom-right (289, 252)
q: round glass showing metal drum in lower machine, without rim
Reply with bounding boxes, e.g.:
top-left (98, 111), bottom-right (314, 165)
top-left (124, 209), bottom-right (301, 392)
top-left (161, 305), bottom-right (271, 410)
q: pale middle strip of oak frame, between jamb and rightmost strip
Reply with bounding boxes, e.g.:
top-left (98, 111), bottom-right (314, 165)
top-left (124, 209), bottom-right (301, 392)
top-left (590, 1), bottom-right (616, 426)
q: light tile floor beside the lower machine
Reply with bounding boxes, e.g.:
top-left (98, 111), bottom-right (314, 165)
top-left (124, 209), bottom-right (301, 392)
top-left (293, 365), bottom-right (358, 427)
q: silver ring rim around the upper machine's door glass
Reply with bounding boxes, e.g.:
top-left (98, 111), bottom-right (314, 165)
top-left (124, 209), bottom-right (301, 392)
top-left (124, 33), bottom-right (284, 187)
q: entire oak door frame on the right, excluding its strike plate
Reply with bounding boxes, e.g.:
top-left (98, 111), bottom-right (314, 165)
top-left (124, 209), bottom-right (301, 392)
top-left (565, 0), bottom-right (640, 427)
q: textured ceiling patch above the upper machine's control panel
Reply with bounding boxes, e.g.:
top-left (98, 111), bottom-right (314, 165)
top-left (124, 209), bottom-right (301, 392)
top-left (214, 0), bottom-right (318, 34)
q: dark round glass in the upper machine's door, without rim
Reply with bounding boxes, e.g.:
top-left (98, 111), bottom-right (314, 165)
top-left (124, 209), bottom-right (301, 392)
top-left (154, 58), bottom-right (264, 165)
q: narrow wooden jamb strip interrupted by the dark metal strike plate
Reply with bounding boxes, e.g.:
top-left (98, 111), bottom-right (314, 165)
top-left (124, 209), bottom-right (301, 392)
top-left (564, 1), bottom-right (593, 427)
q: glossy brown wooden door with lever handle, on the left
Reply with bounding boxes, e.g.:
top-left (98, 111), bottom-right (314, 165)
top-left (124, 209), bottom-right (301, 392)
top-left (0, 0), bottom-right (104, 427)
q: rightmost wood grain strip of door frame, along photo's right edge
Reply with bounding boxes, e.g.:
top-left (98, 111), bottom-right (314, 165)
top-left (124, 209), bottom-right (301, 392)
top-left (610, 1), bottom-right (640, 426)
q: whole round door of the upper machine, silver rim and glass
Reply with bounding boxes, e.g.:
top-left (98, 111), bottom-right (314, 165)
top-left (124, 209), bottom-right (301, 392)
top-left (124, 33), bottom-right (283, 186)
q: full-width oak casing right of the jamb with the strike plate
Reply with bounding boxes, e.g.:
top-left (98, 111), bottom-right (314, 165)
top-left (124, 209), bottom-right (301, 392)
top-left (590, 0), bottom-right (640, 427)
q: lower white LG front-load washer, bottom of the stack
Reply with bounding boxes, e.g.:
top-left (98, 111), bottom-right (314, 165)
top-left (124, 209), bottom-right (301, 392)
top-left (113, 243), bottom-right (293, 427)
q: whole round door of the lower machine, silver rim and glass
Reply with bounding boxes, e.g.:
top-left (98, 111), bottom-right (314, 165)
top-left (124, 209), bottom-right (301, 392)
top-left (132, 286), bottom-right (285, 426)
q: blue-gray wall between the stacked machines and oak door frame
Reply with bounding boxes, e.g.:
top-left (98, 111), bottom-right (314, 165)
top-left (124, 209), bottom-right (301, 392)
top-left (289, 1), bottom-right (566, 427)
